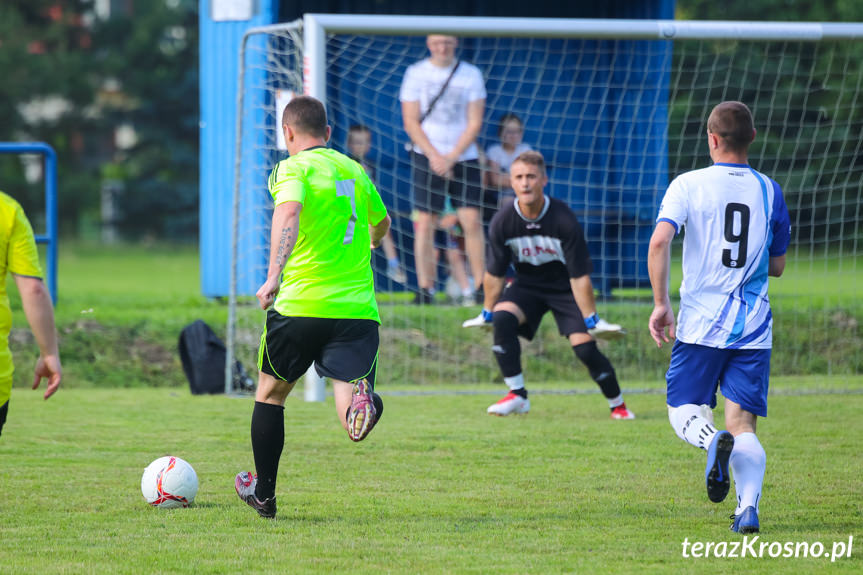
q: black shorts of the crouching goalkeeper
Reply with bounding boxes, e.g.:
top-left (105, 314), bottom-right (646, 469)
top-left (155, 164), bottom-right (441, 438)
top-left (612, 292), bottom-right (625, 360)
top-left (499, 279), bottom-right (587, 340)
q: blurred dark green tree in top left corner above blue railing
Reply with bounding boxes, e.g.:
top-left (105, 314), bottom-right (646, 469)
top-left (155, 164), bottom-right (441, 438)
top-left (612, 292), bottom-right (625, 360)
top-left (0, 0), bottom-right (98, 226)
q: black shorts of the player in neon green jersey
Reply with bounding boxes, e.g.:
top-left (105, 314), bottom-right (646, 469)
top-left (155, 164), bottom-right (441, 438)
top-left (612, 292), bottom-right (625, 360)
top-left (258, 309), bottom-right (380, 387)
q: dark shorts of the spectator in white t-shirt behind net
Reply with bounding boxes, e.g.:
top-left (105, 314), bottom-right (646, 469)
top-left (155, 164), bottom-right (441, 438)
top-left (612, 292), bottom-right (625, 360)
top-left (411, 152), bottom-right (483, 214)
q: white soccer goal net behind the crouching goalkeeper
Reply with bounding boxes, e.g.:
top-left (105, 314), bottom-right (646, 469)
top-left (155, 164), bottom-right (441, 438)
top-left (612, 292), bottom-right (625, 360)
top-left (228, 16), bottom-right (863, 396)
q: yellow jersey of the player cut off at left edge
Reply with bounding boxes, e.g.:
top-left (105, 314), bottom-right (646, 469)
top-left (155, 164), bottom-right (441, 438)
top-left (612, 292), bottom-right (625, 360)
top-left (0, 192), bottom-right (42, 405)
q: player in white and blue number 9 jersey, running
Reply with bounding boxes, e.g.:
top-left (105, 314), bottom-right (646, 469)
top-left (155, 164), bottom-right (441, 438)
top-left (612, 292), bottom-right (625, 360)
top-left (647, 102), bottom-right (791, 533)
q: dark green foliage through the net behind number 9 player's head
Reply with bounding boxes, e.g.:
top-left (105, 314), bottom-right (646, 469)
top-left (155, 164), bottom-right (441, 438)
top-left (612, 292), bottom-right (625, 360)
top-left (668, 32), bottom-right (863, 250)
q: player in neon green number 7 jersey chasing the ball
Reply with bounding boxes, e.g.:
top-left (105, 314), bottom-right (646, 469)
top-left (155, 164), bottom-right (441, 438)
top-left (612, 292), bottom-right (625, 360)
top-left (234, 96), bottom-right (390, 517)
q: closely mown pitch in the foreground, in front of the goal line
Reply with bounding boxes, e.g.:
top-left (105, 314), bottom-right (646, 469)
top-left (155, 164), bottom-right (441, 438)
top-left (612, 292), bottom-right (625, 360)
top-left (0, 388), bottom-right (863, 575)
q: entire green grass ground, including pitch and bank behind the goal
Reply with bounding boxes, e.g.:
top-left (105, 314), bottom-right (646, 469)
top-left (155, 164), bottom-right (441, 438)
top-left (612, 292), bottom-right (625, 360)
top-left (0, 245), bottom-right (863, 574)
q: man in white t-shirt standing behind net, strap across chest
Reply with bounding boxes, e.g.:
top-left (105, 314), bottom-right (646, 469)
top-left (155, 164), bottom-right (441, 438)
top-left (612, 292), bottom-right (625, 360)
top-left (399, 34), bottom-right (486, 304)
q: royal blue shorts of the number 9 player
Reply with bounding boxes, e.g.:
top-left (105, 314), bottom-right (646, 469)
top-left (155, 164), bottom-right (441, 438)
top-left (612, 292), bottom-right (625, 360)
top-left (665, 340), bottom-right (771, 417)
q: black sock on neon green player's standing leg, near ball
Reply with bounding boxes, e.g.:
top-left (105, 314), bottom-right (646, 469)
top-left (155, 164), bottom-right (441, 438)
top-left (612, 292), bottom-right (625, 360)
top-left (252, 401), bottom-right (285, 501)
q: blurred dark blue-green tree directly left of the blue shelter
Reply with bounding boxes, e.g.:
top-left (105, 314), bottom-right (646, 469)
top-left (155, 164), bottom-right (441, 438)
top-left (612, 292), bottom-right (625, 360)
top-left (95, 2), bottom-right (199, 239)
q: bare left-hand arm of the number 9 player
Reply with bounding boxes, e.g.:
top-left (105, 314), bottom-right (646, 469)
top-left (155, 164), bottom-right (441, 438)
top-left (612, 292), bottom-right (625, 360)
top-left (647, 222), bottom-right (675, 347)
